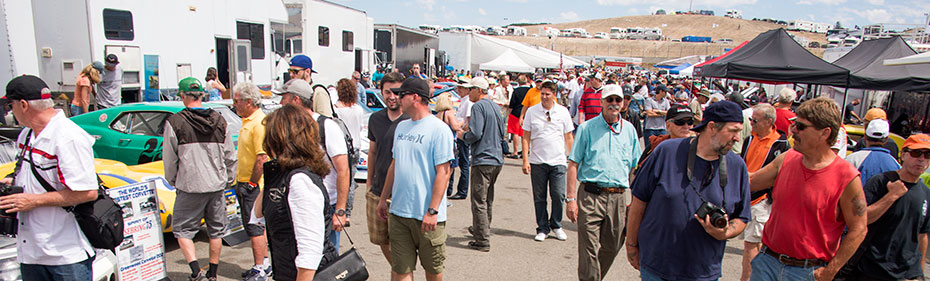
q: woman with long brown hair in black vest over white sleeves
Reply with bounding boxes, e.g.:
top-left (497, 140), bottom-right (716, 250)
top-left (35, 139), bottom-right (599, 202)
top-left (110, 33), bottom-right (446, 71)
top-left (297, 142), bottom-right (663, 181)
top-left (256, 104), bottom-right (338, 281)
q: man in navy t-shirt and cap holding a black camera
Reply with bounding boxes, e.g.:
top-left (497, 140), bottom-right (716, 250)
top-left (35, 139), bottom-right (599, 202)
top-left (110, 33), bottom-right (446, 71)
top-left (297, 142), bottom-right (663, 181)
top-left (626, 101), bottom-right (750, 280)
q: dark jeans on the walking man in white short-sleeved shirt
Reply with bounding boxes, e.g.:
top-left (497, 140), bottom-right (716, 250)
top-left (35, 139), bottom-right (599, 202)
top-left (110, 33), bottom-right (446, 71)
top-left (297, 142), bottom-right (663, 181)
top-left (530, 164), bottom-right (565, 234)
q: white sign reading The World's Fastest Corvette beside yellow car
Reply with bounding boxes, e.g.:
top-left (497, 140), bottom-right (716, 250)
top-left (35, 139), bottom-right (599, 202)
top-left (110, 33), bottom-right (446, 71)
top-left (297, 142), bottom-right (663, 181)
top-left (107, 181), bottom-right (168, 281)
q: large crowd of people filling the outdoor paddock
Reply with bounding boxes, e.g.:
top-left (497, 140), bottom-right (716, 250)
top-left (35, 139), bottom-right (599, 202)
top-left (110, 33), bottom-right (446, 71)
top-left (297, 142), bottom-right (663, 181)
top-left (0, 50), bottom-right (930, 280)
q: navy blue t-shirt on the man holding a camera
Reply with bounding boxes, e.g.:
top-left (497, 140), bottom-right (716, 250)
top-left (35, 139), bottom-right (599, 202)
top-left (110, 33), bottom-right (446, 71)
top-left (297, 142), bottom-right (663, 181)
top-left (632, 138), bottom-right (750, 280)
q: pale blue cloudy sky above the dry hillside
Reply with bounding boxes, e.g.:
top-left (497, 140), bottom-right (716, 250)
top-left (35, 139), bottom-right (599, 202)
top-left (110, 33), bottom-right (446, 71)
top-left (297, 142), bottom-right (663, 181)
top-left (331, 0), bottom-right (930, 30)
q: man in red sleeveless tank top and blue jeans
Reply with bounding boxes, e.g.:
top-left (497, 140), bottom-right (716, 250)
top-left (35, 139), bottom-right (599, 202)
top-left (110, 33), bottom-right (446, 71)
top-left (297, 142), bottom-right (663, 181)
top-left (750, 97), bottom-right (868, 280)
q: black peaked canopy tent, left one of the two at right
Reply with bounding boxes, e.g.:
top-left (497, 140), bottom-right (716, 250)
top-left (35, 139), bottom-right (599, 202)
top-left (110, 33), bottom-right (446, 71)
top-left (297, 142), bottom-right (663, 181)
top-left (695, 28), bottom-right (849, 87)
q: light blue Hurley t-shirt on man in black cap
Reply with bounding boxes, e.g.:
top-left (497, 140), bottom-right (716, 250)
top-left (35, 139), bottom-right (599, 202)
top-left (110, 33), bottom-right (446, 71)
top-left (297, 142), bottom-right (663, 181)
top-left (390, 115), bottom-right (455, 222)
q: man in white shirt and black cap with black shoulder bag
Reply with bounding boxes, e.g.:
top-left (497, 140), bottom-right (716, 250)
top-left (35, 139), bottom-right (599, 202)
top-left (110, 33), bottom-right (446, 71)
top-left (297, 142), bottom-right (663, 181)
top-left (0, 75), bottom-right (97, 281)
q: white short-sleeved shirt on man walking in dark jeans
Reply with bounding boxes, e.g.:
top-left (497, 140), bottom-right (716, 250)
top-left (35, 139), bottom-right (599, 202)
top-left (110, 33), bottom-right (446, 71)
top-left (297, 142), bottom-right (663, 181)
top-left (523, 103), bottom-right (575, 166)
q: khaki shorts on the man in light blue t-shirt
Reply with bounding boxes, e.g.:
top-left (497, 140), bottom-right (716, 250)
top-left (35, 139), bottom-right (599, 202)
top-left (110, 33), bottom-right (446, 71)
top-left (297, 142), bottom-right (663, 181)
top-left (388, 214), bottom-right (446, 274)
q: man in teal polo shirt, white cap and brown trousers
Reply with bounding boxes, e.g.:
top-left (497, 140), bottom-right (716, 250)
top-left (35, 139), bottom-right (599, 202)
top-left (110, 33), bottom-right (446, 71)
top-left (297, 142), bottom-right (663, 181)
top-left (565, 85), bottom-right (643, 280)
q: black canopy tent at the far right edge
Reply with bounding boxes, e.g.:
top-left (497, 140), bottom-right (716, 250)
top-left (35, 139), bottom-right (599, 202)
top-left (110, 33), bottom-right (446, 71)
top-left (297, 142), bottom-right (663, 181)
top-left (833, 36), bottom-right (930, 92)
